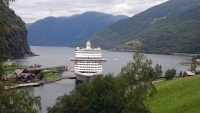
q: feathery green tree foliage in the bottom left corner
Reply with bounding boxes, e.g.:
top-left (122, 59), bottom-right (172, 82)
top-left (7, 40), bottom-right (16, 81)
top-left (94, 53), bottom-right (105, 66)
top-left (0, 84), bottom-right (41, 113)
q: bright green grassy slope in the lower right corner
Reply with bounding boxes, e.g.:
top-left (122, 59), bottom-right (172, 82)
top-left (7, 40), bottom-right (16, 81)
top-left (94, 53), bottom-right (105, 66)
top-left (149, 75), bottom-right (200, 113)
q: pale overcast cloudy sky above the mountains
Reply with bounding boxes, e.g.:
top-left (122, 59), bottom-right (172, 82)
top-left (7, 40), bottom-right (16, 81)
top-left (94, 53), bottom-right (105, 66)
top-left (10, 0), bottom-right (168, 23)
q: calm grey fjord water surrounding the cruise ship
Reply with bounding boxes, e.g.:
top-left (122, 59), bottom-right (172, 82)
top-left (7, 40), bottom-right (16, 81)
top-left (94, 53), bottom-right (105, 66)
top-left (14, 46), bottom-right (191, 113)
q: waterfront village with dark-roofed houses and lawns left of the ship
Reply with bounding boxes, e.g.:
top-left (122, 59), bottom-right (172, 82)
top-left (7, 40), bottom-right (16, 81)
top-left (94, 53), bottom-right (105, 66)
top-left (1, 61), bottom-right (67, 84)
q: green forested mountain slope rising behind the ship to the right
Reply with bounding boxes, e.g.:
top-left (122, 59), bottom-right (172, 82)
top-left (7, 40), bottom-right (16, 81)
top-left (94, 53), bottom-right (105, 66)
top-left (76, 0), bottom-right (200, 54)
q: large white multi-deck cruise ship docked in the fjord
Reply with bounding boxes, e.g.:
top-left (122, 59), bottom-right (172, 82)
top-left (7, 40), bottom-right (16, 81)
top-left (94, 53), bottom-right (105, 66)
top-left (70, 41), bottom-right (107, 82)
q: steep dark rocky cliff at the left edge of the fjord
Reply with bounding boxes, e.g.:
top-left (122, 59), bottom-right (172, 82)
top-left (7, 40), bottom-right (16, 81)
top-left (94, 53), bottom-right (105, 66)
top-left (0, 0), bottom-right (34, 58)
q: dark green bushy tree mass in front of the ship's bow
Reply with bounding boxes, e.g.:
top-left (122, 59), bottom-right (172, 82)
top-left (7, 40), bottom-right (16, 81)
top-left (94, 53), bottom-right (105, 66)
top-left (47, 74), bottom-right (124, 113)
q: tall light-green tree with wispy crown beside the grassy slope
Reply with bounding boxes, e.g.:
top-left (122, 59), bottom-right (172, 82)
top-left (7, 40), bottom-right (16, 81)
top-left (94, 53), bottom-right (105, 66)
top-left (120, 51), bottom-right (156, 113)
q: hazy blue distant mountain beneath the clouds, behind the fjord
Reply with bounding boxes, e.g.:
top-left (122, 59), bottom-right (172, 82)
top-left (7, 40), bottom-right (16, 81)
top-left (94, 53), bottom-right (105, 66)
top-left (27, 12), bottom-right (127, 46)
